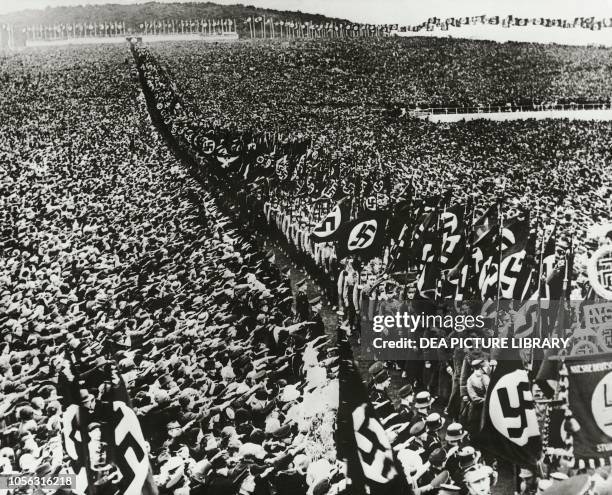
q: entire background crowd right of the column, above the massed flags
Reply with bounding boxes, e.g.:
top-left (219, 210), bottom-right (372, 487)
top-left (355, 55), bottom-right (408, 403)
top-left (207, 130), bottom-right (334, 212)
top-left (154, 39), bottom-right (610, 264)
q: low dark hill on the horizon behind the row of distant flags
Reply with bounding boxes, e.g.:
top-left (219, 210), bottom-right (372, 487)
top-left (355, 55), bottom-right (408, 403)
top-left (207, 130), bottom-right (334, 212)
top-left (0, 2), bottom-right (348, 34)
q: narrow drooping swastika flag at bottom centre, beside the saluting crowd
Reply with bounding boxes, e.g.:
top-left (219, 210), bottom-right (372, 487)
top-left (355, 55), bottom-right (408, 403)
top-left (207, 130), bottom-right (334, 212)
top-left (336, 329), bottom-right (411, 495)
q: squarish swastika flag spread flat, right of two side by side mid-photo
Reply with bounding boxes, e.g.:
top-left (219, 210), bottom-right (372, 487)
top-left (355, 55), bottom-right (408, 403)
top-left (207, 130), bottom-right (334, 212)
top-left (336, 211), bottom-right (387, 261)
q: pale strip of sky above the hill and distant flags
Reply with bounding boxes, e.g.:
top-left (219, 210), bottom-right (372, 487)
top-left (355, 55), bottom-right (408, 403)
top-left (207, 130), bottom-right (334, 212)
top-left (0, 0), bottom-right (612, 24)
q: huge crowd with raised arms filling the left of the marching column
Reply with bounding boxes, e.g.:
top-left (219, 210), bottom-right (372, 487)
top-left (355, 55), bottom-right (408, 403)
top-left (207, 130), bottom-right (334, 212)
top-left (0, 43), bottom-right (342, 495)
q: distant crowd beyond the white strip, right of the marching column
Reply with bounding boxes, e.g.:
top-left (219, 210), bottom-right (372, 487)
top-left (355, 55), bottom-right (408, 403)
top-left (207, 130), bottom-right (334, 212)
top-left (155, 38), bottom-right (612, 114)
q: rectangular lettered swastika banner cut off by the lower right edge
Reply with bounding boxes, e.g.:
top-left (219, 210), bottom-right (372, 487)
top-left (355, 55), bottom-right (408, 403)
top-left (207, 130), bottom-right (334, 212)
top-left (566, 353), bottom-right (612, 464)
